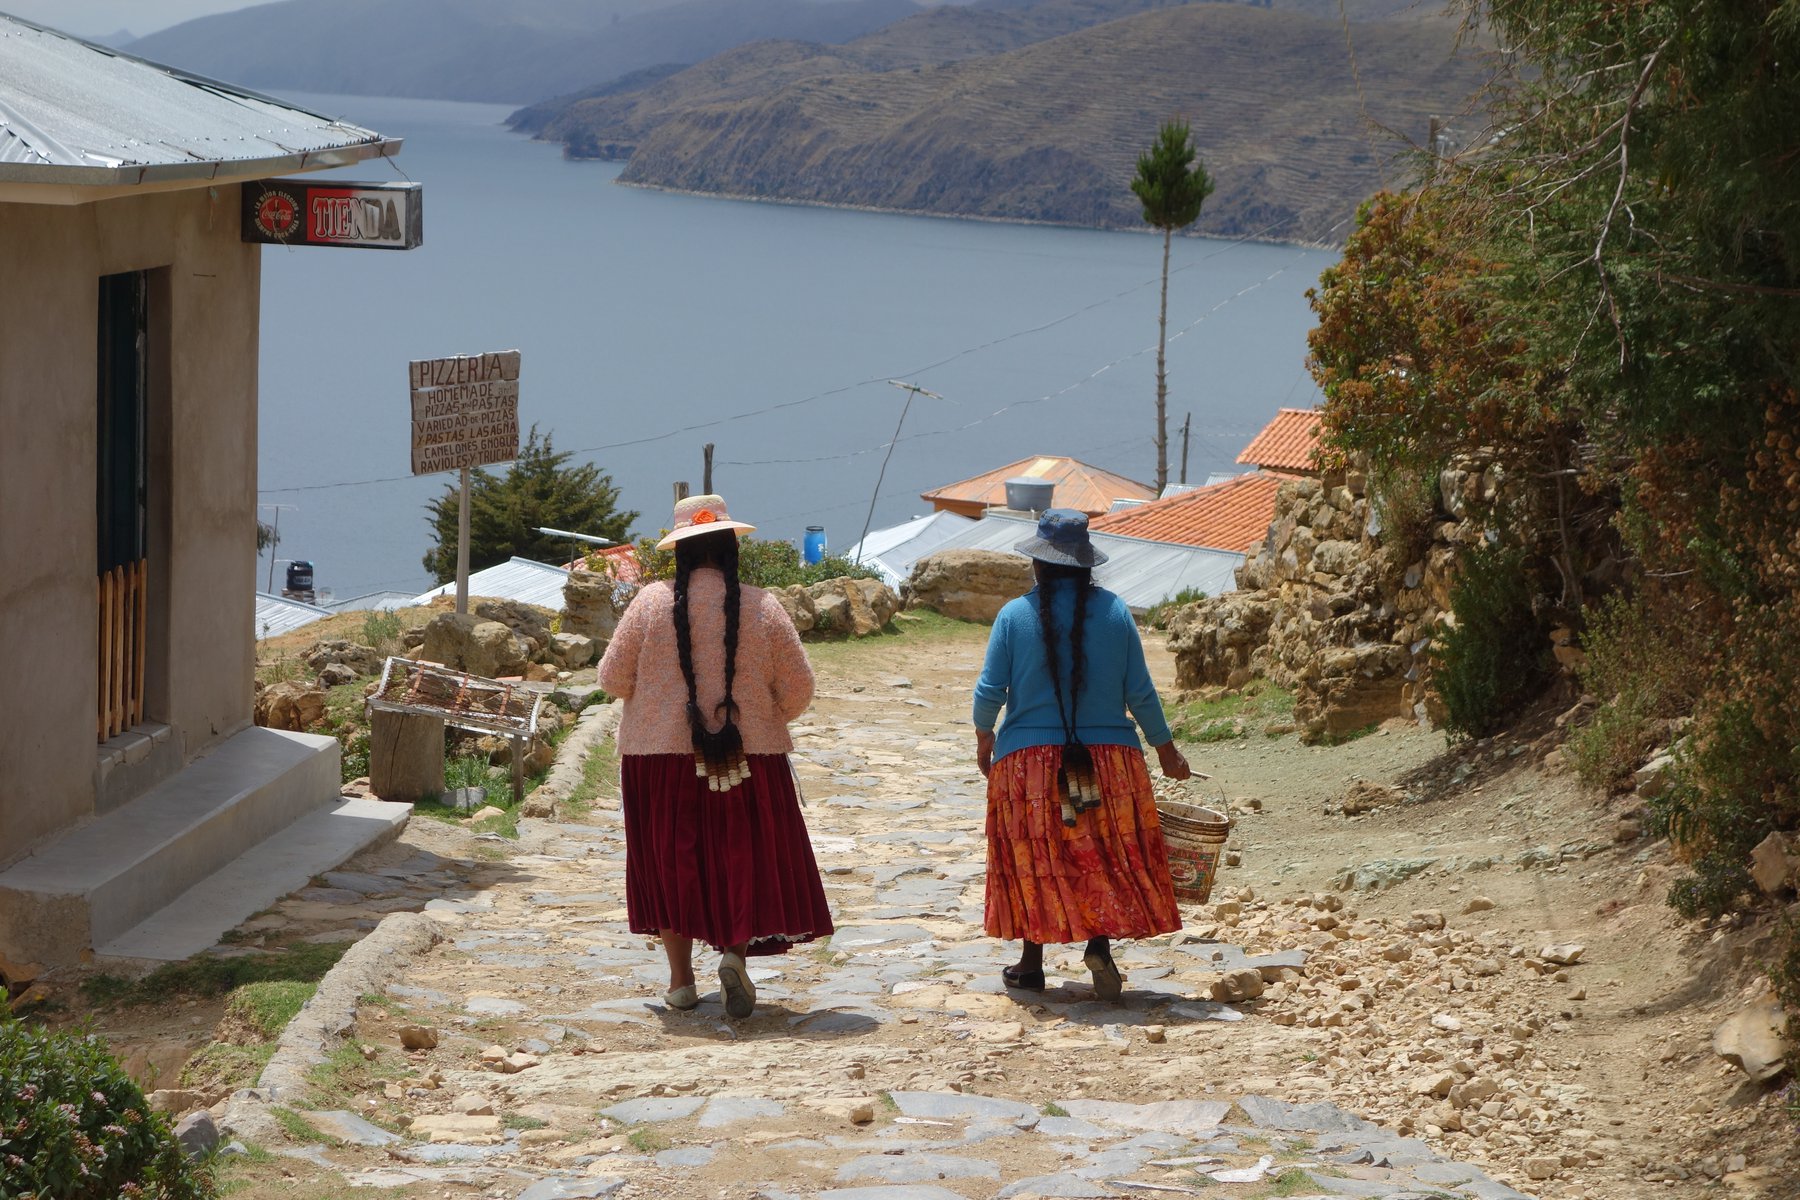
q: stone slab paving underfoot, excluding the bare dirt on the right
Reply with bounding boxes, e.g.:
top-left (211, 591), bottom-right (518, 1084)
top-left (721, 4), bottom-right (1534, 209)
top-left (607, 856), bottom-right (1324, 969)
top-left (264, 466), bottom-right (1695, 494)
top-left (266, 644), bottom-right (1580, 1200)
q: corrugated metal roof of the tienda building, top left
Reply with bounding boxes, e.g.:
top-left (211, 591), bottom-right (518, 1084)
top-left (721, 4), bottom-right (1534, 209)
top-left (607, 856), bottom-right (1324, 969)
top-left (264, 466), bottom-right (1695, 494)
top-left (0, 14), bottom-right (400, 185)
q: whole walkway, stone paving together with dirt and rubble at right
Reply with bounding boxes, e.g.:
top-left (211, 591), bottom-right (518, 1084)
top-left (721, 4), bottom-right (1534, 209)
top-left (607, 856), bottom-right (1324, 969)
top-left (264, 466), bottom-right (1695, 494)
top-left (179, 622), bottom-right (1793, 1200)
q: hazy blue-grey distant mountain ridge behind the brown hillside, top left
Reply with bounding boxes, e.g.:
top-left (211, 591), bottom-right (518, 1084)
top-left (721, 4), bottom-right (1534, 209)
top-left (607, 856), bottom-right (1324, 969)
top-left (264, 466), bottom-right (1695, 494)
top-left (124, 0), bottom-right (918, 104)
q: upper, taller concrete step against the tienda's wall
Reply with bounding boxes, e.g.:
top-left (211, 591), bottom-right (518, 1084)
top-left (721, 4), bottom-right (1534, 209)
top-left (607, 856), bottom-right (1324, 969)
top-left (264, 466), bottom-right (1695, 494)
top-left (0, 727), bottom-right (342, 963)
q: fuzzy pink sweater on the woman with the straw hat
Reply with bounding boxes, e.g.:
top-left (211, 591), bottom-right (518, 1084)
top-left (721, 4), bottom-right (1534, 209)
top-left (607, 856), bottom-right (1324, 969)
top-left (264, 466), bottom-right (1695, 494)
top-left (599, 567), bottom-right (812, 754)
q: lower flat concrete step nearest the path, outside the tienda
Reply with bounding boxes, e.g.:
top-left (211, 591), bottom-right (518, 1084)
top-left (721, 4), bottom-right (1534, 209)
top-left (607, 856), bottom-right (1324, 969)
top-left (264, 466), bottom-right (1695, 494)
top-left (95, 799), bottom-right (412, 963)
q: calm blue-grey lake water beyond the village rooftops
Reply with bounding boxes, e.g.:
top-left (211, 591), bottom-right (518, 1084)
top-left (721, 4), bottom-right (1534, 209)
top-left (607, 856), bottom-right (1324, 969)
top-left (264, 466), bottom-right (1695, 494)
top-left (257, 95), bottom-right (1336, 599)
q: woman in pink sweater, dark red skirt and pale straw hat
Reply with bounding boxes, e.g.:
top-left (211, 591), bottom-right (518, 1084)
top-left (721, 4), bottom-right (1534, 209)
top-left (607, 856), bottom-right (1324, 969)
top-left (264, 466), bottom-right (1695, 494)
top-left (599, 497), bottom-right (832, 1016)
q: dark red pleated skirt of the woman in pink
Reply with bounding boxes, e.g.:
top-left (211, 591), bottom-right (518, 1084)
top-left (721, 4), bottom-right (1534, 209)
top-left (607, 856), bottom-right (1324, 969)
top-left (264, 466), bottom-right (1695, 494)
top-left (619, 754), bottom-right (832, 954)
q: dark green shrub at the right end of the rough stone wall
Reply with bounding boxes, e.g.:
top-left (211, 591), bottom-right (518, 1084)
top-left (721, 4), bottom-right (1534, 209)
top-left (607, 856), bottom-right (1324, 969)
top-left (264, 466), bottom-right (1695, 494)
top-left (1433, 545), bottom-right (1550, 738)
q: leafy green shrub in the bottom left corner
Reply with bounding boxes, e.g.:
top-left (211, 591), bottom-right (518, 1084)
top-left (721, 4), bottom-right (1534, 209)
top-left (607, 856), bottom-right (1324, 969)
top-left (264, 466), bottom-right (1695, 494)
top-left (0, 1013), bottom-right (214, 1200)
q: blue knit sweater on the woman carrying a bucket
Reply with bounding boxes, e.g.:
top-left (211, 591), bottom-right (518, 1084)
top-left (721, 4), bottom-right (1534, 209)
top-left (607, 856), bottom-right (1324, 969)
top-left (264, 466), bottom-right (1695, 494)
top-left (974, 583), bottom-right (1170, 759)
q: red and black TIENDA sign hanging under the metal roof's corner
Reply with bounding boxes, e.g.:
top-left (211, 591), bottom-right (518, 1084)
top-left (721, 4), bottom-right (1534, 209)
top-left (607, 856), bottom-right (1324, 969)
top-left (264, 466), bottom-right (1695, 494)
top-left (243, 180), bottom-right (425, 250)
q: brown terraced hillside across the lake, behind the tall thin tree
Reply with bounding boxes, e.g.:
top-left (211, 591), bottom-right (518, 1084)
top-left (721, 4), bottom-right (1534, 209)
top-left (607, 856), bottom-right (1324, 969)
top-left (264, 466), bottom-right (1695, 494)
top-left (518, 4), bottom-right (1485, 241)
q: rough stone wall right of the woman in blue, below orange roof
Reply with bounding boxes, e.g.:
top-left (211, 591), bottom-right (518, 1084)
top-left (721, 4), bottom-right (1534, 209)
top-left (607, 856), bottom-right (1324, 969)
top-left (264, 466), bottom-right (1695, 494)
top-left (1170, 468), bottom-right (1501, 739)
